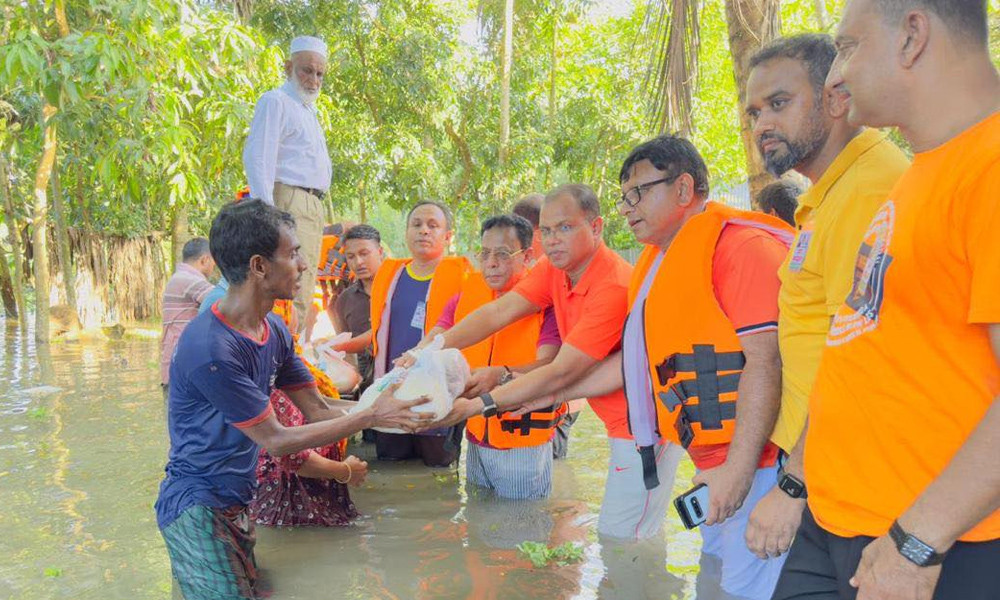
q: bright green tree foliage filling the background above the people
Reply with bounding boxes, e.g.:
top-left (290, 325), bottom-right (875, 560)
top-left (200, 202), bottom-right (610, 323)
top-left (0, 0), bottom-right (1000, 252)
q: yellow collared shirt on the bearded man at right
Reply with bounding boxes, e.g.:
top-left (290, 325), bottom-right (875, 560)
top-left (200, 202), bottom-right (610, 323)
top-left (771, 129), bottom-right (910, 452)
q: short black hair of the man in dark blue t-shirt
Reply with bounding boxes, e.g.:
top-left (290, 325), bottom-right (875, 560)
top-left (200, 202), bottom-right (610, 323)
top-left (208, 199), bottom-right (295, 285)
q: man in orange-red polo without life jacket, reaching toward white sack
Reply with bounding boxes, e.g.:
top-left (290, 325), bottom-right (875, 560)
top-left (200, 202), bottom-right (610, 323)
top-left (410, 184), bottom-right (681, 539)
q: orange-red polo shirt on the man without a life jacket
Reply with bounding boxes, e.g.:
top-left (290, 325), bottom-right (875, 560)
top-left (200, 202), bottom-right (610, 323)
top-left (514, 242), bottom-right (632, 439)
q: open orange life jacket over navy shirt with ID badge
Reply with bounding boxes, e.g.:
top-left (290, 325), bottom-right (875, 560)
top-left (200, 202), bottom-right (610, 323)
top-left (371, 256), bottom-right (472, 377)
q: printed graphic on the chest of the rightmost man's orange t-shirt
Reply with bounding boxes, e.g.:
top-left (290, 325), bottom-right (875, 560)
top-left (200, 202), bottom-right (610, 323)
top-left (826, 200), bottom-right (896, 346)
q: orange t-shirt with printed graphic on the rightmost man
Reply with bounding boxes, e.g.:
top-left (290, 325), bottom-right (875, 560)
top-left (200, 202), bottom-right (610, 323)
top-left (805, 112), bottom-right (1000, 542)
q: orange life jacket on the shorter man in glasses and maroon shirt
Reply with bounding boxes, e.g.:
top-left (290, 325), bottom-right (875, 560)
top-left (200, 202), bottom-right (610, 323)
top-left (455, 271), bottom-right (566, 450)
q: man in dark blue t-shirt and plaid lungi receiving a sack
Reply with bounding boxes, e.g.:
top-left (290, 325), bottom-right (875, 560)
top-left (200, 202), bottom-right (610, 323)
top-left (156, 200), bottom-right (425, 599)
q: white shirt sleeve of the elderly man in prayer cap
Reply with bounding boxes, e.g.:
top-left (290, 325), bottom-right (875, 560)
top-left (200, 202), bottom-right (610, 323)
top-left (243, 93), bottom-right (284, 205)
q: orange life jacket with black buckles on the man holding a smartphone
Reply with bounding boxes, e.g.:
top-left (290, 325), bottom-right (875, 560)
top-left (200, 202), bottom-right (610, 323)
top-left (626, 202), bottom-right (792, 460)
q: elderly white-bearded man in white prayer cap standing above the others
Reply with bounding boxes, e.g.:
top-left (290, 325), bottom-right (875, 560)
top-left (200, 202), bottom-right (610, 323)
top-left (243, 36), bottom-right (332, 324)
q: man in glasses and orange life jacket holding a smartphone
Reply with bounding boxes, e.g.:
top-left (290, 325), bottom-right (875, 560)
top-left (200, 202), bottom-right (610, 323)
top-left (556, 136), bottom-right (792, 600)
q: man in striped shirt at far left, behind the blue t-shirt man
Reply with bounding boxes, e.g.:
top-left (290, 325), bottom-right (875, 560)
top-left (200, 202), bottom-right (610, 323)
top-left (160, 237), bottom-right (215, 393)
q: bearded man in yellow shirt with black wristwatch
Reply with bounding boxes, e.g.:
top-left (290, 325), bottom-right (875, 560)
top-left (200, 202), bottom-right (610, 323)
top-left (746, 34), bottom-right (909, 558)
